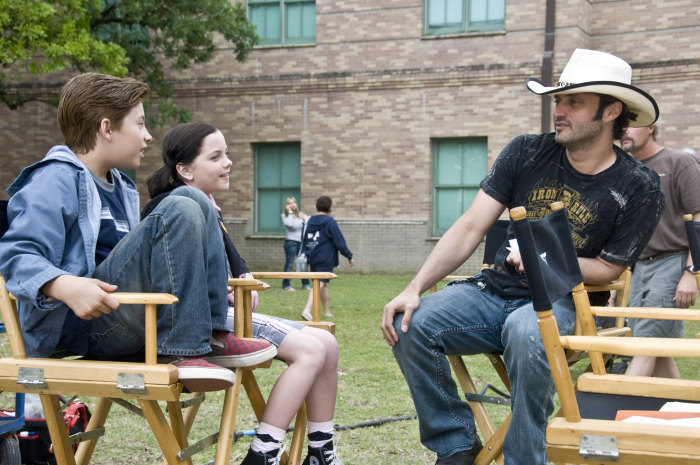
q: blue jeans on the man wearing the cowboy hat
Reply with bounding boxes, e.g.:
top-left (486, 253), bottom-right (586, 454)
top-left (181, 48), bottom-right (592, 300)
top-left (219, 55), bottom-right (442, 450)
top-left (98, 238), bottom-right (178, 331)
top-left (393, 275), bottom-right (575, 465)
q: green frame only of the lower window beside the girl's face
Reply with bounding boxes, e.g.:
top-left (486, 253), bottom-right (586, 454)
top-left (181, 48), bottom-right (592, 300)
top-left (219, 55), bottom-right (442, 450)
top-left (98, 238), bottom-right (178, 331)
top-left (252, 141), bottom-right (301, 236)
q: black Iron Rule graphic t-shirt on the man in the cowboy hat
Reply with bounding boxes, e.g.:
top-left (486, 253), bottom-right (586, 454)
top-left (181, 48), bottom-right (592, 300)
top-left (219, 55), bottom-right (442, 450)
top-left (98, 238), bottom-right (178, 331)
top-left (481, 133), bottom-right (664, 296)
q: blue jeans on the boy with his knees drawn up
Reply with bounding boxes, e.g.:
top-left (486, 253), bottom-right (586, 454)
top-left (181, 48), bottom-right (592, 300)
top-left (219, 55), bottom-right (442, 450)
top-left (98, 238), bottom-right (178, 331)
top-left (89, 187), bottom-right (228, 359)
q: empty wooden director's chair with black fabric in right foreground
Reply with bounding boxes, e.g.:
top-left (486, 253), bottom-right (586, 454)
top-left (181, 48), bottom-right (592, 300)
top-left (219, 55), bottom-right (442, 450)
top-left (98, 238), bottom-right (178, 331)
top-left (511, 202), bottom-right (700, 465)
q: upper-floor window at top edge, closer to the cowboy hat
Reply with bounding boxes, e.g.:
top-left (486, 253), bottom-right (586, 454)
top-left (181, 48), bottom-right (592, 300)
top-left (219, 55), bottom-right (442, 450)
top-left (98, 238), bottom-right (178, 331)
top-left (424, 0), bottom-right (506, 35)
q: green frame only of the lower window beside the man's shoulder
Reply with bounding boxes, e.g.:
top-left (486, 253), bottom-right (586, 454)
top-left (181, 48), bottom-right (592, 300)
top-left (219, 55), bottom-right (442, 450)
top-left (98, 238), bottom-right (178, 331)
top-left (430, 136), bottom-right (488, 237)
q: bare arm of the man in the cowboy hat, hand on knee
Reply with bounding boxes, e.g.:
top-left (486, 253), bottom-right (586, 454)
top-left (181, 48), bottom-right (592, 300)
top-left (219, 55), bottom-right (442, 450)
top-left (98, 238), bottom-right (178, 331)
top-left (381, 190), bottom-right (505, 346)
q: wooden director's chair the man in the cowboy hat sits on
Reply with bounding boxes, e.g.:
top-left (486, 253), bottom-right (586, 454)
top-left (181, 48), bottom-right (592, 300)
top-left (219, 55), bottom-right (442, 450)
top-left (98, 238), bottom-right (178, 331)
top-left (430, 212), bottom-right (631, 465)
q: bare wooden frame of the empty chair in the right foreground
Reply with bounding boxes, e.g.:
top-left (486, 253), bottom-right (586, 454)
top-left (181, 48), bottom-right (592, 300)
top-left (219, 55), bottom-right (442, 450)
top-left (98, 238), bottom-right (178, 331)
top-left (511, 207), bottom-right (700, 465)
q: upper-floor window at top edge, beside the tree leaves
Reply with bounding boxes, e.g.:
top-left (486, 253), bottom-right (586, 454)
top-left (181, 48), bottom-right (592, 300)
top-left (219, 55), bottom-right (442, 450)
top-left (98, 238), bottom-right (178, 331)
top-left (248, 0), bottom-right (316, 45)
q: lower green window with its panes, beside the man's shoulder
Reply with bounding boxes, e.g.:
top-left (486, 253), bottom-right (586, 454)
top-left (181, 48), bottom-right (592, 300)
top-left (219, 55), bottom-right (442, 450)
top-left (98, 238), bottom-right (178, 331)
top-left (432, 137), bottom-right (487, 236)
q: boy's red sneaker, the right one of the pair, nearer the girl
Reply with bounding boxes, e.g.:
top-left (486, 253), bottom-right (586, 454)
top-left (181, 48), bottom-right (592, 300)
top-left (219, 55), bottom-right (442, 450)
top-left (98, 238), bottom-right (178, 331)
top-left (204, 331), bottom-right (277, 368)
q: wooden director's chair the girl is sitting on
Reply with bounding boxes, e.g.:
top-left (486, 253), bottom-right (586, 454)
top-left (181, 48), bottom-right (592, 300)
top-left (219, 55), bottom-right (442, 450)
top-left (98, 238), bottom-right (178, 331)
top-left (229, 272), bottom-right (336, 465)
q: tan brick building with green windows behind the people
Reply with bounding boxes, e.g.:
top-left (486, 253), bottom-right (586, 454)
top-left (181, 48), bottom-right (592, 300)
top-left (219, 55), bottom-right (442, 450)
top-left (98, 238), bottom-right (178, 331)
top-left (0, 0), bottom-right (700, 273)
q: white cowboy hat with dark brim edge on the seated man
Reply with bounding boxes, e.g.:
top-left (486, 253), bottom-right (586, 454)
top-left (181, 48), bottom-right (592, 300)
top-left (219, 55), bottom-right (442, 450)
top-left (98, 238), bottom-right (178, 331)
top-left (527, 48), bottom-right (659, 127)
